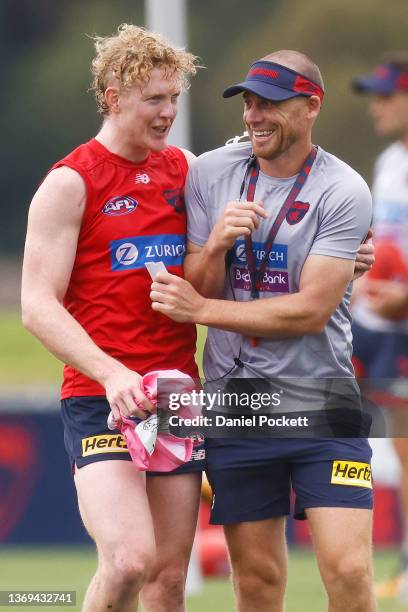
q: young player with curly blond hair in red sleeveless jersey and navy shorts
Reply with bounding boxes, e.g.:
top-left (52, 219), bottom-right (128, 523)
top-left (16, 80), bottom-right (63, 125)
top-left (22, 24), bottom-right (202, 612)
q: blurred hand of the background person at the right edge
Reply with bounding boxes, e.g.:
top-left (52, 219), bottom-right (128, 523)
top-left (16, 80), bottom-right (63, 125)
top-left (364, 280), bottom-right (408, 321)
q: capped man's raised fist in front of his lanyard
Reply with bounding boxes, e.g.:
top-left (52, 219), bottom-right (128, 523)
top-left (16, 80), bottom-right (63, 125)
top-left (208, 202), bottom-right (268, 251)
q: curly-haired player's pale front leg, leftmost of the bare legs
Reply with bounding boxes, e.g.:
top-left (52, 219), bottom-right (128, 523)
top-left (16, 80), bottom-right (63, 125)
top-left (75, 461), bottom-right (155, 612)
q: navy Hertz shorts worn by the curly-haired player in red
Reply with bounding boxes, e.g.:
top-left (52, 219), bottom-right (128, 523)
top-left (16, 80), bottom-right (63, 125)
top-left (61, 396), bottom-right (205, 476)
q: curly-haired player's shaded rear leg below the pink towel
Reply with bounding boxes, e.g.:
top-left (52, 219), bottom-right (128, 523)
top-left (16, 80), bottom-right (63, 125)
top-left (141, 472), bottom-right (201, 612)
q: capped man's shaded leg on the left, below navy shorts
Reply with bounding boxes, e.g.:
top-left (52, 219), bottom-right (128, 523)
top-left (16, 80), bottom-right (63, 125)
top-left (224, 517), bottom-right (287, 612)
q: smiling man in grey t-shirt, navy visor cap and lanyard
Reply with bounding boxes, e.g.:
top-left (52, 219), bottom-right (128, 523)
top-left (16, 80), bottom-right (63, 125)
top-left (151, 51), bottom-right (376, 612)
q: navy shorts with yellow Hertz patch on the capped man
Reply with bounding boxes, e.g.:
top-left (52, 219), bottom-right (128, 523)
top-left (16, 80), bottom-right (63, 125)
top-left (206, 438), bottom-right (373, 525)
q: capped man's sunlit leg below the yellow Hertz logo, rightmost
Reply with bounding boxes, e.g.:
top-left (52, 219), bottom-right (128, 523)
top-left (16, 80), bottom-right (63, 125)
top-left (306, 508), bottom-right (377, 612)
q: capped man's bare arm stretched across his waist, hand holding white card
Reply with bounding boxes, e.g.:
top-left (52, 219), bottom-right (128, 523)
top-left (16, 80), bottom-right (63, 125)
top-left (151, 255), bottom-right (354, 338)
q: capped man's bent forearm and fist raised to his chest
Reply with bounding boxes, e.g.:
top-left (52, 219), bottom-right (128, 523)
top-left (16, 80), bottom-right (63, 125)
top-left (184, 202), bottom-right (268, 298)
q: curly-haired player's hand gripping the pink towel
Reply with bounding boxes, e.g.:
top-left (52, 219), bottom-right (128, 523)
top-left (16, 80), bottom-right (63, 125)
top-left (103, 366), bottom-right (156, 421)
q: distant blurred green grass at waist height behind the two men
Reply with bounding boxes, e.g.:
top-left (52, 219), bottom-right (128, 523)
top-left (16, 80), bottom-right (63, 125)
top-left (0, 310), bottom-right (206, 387)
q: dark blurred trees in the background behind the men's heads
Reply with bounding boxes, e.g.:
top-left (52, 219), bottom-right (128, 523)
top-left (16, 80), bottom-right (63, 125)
top-left (0, 0), bottom-right (407, 256)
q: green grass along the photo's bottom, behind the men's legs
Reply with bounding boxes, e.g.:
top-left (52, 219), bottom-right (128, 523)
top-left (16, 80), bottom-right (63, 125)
top-left (0, 547), bottom-right (401, 612)
